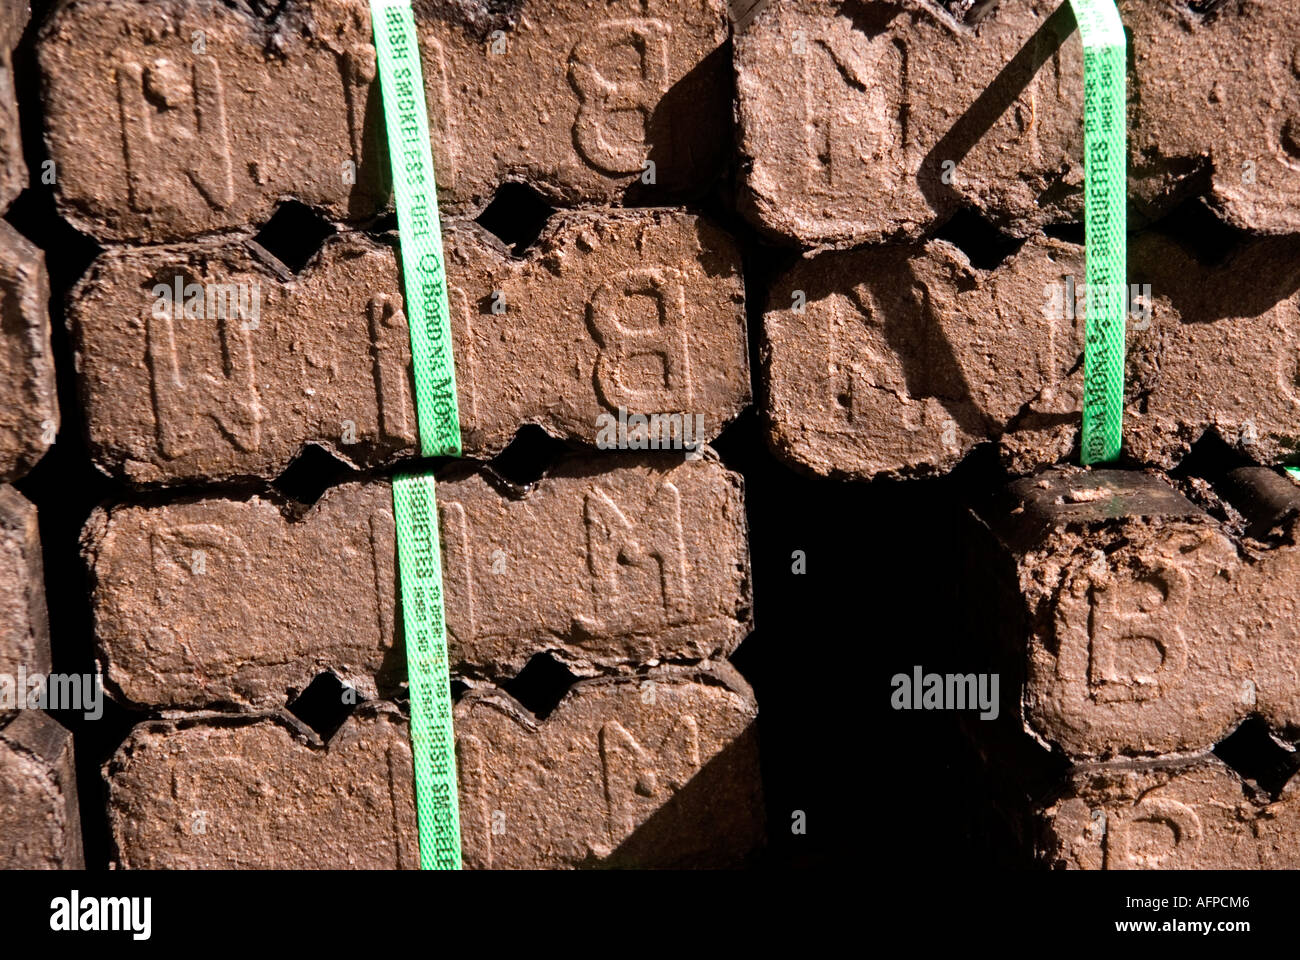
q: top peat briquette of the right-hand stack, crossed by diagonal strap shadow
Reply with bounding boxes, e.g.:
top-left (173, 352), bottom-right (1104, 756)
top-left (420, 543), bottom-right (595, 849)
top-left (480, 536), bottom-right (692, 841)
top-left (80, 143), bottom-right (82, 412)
top-left (735, 0), bottom-right (1300, 247)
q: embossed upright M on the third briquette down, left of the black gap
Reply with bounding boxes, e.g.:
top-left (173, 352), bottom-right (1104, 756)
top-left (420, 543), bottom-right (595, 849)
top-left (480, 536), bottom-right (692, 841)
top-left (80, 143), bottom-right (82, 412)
top-left (579, 483), bottom-right (690, 635)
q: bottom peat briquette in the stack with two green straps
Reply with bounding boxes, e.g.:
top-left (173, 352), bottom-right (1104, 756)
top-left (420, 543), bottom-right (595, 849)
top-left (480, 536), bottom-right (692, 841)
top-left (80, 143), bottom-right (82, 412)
top-left (105, 665), bottom-right (764, 869)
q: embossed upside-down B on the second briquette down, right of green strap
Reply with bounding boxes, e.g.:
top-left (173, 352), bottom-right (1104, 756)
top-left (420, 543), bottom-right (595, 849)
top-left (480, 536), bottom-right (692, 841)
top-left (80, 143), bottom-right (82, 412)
top-left (588, 267), bottom-right (693, 412)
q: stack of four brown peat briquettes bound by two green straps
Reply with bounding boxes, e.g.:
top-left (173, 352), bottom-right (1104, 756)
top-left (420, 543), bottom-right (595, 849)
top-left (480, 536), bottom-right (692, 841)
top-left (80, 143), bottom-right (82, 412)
top-left (38, 0), bottom-right (764, 868)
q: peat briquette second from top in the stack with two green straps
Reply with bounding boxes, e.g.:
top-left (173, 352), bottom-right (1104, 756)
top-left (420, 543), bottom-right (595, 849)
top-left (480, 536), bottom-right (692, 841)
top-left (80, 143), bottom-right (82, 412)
top-left (69, 211), bottom-right (750, 484)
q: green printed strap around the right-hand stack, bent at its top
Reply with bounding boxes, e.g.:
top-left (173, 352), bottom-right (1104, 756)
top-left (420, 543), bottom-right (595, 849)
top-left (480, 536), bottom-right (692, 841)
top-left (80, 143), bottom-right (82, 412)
top-left (1070, 0), bottom-right (1128, 464)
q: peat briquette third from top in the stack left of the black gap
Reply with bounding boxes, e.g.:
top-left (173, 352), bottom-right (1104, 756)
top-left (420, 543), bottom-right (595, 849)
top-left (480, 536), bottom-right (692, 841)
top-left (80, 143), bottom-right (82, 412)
top-left (83, 454), bottom-right (753, 710)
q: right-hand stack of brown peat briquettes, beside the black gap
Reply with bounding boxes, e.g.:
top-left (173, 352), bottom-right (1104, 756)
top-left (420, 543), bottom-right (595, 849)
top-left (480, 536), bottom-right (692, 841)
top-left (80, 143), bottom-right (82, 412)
top-left (736, 0), bottom-right (1300, 868)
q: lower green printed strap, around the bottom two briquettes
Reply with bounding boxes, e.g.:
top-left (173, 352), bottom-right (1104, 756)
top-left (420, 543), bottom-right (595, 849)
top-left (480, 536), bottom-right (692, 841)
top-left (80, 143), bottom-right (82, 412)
top-left (393, 473), bottom-right (460, 870)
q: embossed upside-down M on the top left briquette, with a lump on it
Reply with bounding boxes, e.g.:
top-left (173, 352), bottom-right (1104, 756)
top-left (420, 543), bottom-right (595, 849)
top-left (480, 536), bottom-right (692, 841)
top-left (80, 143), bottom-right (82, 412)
top-left (117, 57), bottom-right (234, 211)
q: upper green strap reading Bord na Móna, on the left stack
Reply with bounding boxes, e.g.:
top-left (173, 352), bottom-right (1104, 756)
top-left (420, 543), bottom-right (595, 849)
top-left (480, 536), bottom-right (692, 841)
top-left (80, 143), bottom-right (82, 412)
top-left (371, 0), bottom-right (460, 457)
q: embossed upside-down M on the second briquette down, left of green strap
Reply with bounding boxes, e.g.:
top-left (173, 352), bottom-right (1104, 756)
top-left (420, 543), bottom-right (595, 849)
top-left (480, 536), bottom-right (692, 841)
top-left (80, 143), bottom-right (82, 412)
top-left (144, 287), bottom-right (265, 459)
